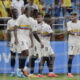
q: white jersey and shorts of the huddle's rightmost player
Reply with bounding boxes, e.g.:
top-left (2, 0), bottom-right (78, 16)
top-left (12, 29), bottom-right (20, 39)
top-left (38, 22), bottom-right (54, 57)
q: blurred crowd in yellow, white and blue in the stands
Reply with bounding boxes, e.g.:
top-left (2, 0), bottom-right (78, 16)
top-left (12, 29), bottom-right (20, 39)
top-left (0, 0), bottom-right (80, 28)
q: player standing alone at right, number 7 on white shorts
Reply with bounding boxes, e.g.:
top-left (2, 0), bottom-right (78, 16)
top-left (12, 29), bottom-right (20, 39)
top-left (67, 12), bottom-right (80, 77)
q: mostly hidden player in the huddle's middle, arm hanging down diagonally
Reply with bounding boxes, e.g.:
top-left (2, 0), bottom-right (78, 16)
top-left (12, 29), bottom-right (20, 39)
top-left (24, 9), bottom-right (43, 77)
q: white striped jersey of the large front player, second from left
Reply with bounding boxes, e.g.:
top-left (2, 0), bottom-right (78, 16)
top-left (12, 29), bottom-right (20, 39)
top-left (16, 15), bottom-right (35, 46)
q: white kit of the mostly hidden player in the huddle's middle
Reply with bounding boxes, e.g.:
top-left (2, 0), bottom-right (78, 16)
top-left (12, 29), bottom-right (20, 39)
top-left (29, 18), bottom-right (40, 57)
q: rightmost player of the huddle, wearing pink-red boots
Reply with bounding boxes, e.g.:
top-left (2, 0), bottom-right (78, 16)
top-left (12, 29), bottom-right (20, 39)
top-left (37, 13), bottom-right (58, 77)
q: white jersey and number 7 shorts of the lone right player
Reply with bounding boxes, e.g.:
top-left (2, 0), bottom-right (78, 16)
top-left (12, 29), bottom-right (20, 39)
top-left (67, 20), bottom-right (80, 55)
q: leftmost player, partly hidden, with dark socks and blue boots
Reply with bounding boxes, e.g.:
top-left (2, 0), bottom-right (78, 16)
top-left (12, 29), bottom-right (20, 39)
top-left (7, 9), bottom-right (18, 76)
